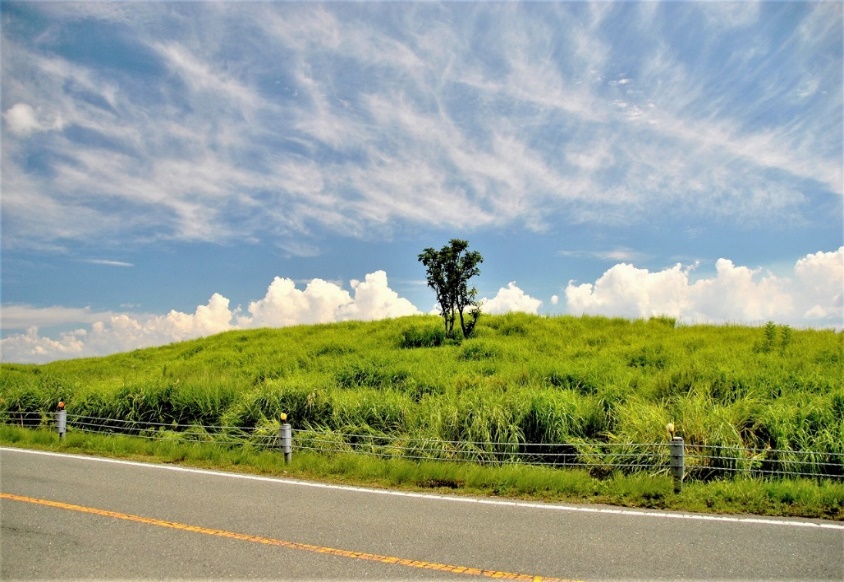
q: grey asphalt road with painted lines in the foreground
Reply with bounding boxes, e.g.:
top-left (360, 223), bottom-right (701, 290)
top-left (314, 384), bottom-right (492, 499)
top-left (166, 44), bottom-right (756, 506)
top-left (0, 448), bottom-right (844, 580)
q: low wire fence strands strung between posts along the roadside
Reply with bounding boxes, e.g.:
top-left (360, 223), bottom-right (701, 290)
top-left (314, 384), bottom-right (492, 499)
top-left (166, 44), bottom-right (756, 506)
top-left (0, 412), bottom-right (844, 481)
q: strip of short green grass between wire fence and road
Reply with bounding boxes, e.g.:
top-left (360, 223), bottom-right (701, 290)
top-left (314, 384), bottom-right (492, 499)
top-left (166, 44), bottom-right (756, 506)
top-left (0, 425), bottom-right (844, 520)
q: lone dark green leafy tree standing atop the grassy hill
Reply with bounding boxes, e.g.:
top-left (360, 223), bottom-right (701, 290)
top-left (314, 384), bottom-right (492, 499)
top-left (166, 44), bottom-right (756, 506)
top-left (419, 238), bottom-right (484, 338)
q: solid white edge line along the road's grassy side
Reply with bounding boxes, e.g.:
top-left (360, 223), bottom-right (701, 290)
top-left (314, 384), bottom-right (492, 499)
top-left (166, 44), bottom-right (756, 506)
top-left (0, 447), bottom-right (844, 530)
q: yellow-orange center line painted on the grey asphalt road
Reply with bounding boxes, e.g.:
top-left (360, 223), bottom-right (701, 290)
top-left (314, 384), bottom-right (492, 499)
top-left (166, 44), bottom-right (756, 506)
top-left (0, 493), bottom-right (576, 582)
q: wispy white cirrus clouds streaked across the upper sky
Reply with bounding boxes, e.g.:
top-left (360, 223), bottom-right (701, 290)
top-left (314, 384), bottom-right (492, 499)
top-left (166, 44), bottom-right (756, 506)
top-left (2, 3), bottom-right (844, 256)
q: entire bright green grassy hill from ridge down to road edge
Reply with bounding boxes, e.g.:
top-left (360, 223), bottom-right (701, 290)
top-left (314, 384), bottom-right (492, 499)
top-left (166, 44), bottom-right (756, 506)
top-left (0, 314), bottom-right (844, 520)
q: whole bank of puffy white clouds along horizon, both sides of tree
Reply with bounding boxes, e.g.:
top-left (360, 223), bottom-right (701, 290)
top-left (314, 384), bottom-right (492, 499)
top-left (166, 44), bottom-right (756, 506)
top-left (0, 247), bottom-right (844, 363)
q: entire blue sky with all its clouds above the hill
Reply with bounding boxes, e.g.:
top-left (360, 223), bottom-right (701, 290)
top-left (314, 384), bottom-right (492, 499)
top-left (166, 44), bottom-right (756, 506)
top-left (0, 1), bottom-right (844, 362)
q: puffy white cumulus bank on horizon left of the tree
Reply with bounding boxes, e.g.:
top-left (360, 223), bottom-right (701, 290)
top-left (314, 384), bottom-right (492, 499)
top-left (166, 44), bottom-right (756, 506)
top-left (0, 271), bottom-right (419, 363)
